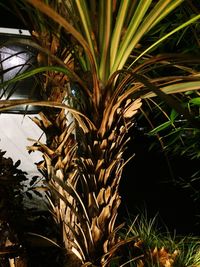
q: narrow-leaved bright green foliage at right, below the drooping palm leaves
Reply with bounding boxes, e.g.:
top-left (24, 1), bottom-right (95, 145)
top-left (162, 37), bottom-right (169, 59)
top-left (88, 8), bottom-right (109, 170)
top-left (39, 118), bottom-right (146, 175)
top-left (143, 92), bottom-right (200, 160)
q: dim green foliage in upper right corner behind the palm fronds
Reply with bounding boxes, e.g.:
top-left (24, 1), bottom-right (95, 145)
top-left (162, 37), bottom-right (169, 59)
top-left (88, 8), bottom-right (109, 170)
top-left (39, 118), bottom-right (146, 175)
top-left (142, 1), bottom-right (200, 55)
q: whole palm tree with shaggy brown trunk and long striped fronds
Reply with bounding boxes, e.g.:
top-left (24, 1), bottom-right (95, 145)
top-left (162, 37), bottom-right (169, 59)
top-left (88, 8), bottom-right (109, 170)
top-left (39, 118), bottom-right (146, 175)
top-left (1, 0), bottom-right (200, 266)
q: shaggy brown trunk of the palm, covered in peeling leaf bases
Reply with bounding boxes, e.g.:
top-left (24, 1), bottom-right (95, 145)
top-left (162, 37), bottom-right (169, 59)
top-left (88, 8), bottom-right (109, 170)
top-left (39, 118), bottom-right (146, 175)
top-left (29, 93), bottom-right (141, 266)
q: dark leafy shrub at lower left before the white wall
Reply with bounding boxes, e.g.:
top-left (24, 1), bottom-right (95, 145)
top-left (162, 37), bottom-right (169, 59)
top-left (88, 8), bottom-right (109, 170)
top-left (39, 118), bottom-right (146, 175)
top-left (0, 150), bottom-right (62, 267)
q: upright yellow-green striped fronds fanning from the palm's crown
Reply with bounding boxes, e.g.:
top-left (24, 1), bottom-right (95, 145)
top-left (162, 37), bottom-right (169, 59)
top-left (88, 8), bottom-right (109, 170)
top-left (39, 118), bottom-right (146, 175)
top-left (22, 0), bottom-right (199, 88)
